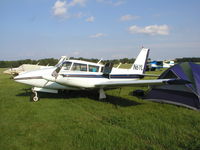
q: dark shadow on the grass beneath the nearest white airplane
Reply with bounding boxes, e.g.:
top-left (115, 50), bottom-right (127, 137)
top-left (16, 89), bottom-right (142, 107)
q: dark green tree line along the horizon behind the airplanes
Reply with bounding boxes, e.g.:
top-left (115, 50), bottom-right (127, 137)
top-left (0, 57), bottom-right (200, 68)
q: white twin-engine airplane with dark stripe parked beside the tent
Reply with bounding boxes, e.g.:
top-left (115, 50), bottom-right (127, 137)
top-left (14, 48), bottom-right (184, 102)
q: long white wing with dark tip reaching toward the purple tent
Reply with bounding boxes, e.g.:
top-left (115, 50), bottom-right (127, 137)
top-left (95, 79), bottom-right (191, 88)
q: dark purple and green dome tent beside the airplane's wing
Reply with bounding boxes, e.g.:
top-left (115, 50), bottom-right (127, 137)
top-left (145, 62), bottom-right (200, 110)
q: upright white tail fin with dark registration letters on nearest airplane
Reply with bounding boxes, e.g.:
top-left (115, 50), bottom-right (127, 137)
top-left (130, 48), bottom-right (150, 74)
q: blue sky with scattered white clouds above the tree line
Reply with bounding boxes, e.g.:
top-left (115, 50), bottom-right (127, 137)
top-left (0, 0), bottom-right (200, 60)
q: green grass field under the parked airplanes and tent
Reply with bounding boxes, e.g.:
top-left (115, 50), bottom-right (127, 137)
top-left (0, 69), bottom-right (200, 150)
